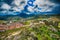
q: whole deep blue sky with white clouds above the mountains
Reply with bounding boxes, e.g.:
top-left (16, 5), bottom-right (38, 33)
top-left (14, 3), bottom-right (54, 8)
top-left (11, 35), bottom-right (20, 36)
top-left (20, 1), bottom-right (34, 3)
top-left (0, 0), bottom-right (60, 15)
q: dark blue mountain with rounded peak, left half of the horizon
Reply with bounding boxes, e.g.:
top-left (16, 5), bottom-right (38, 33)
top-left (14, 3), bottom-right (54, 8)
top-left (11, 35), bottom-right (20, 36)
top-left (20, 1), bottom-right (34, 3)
top-left (0, 13), bottom-right (35, 20)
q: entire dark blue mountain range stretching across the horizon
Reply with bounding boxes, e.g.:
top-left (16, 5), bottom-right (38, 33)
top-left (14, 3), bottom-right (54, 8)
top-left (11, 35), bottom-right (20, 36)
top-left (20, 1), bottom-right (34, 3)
top-left (0, 12), bottom-right (60, 20)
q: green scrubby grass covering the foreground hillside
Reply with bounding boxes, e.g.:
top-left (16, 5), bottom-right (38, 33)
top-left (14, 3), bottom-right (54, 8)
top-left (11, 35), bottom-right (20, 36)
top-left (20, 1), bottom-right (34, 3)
top-left (0, 18), bottom-right (60, 40)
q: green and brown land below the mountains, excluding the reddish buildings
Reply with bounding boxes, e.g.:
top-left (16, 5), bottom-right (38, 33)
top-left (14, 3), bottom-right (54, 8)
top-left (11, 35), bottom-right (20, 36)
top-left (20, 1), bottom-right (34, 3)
top-left (0, 16), bottom-right (60, 40)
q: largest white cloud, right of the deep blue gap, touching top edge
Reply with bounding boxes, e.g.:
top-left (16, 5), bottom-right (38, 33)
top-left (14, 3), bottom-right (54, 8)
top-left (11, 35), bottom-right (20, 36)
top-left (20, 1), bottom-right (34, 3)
top-left (33, 0), bottom-right (55, 12)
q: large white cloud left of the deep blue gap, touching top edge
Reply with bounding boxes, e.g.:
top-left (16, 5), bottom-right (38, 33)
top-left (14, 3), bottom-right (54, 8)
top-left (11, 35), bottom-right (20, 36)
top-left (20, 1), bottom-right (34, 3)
top-left (12, 0), bottom-right (27, 11)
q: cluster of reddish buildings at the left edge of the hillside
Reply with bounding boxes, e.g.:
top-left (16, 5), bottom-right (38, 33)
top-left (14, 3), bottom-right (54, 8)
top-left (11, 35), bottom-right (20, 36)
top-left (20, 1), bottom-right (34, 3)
top-left (0, 22), bottom-right (23, 31)
